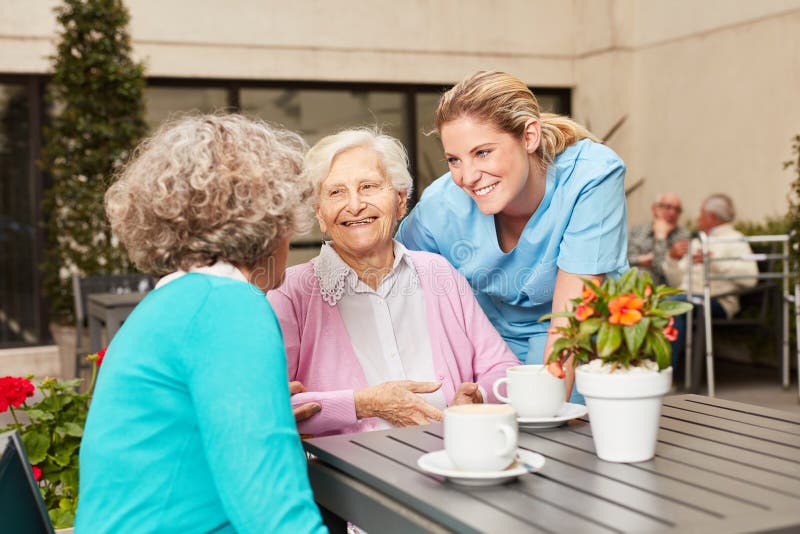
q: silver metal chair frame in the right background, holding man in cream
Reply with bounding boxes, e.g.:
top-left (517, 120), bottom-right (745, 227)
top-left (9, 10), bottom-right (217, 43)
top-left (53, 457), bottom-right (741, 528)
top-left (685, 232), bottom-right (800, 397)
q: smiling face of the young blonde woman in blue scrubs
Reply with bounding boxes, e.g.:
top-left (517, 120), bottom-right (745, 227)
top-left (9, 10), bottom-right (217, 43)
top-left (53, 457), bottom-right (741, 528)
top-left (440, 116), bottom-right (541, 215)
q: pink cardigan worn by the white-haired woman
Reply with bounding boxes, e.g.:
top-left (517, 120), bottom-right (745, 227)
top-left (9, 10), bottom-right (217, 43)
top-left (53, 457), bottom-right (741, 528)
top-left (267, 251), bottom-right (520, 436)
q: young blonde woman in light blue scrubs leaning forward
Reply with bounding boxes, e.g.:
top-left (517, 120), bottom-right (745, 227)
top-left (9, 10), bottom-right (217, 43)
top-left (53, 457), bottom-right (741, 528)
top-left (396, 72), bottom-right (628, 402)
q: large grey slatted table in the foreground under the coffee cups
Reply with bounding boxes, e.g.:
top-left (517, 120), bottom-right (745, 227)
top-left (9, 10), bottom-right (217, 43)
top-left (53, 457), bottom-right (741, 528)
top-left (304, 395), bottom-right (800, 533)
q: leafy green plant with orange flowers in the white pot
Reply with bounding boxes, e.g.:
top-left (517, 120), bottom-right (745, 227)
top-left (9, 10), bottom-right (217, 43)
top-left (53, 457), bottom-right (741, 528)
top-left (542, 269), bottom-right (692, 369)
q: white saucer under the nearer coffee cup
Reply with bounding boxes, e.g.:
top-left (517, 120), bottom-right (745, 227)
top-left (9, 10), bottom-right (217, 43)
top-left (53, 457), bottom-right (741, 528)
top-left (417, 449), bottom-right (544, 486)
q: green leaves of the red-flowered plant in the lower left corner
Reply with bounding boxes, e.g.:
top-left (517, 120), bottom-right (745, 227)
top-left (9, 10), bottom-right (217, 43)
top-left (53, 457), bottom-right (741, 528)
top-left (0, 364), bottom-right (98, 528)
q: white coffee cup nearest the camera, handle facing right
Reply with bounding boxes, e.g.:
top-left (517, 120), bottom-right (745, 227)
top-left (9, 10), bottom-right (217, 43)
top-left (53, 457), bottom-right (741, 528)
top-left (444, 404), bottom-right (517, 472)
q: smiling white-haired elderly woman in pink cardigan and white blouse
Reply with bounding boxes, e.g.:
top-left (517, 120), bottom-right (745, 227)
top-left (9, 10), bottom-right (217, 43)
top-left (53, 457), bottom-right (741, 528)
top-left (268, 129), bottom-right (519, 435)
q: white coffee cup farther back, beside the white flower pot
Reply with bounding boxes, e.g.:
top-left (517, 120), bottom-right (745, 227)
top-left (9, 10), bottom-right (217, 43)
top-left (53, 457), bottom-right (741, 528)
top-left (492, 365), bottom-right (567, 418)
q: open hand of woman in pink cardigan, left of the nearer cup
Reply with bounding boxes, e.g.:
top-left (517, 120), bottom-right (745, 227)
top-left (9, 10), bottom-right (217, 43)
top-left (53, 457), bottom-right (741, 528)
top-left (354, 380), bottom-right (442, 426)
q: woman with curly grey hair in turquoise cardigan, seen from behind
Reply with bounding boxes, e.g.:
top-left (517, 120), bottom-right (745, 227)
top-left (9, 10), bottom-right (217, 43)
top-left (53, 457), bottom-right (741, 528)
top-left (76, 115), bottom-right (325, 532)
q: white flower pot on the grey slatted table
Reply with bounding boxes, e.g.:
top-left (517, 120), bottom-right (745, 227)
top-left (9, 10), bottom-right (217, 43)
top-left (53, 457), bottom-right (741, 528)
top-left (575, 366), bottom-right (672, 462)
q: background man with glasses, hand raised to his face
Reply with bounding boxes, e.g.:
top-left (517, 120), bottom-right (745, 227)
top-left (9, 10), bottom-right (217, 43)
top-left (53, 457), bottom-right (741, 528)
top-left (628, 193), bottom-right (689, 284)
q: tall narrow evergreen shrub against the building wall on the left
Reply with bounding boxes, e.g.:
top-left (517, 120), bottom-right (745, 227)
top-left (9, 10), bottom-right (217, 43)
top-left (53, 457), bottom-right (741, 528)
top-left (41, 0), bottom-right (147, 321)
